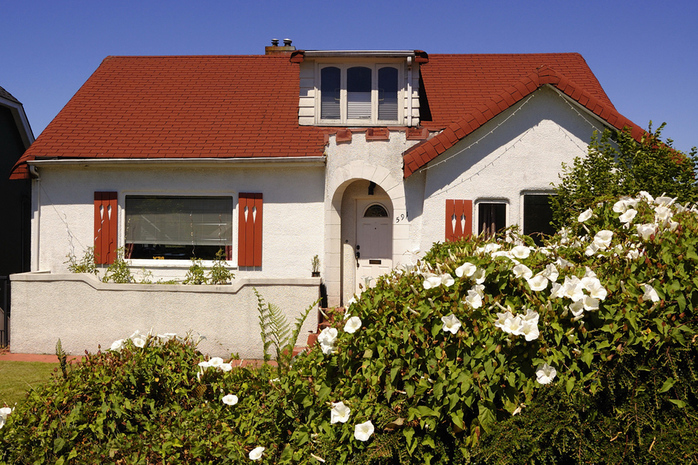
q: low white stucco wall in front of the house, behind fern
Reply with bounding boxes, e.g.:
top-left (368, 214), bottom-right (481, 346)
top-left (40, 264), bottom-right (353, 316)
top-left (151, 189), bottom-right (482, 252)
top-left (11, 273), bottom-right (320, 359)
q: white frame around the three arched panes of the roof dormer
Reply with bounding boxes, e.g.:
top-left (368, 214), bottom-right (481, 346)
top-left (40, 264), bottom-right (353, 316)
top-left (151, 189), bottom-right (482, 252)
top-left (315, 61), bottom-right (405, 126)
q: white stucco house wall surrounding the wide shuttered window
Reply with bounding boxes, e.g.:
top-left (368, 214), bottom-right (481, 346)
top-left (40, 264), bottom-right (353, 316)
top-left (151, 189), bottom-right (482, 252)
top-left (32, 162), bottom-right (324, 280)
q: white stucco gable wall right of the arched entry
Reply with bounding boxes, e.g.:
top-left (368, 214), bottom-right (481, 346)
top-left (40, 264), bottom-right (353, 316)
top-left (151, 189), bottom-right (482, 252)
top-left (414, 87), bottom-right (598, 251)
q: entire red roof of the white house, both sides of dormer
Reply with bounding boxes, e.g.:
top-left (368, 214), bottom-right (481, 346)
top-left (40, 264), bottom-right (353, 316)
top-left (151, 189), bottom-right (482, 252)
top-left (12, 53), bottom-right (634, 178)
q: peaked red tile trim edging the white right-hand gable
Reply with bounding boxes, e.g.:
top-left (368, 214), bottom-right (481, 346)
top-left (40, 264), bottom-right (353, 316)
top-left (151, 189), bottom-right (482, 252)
top-left (403, 66), bottom-right (645, 178)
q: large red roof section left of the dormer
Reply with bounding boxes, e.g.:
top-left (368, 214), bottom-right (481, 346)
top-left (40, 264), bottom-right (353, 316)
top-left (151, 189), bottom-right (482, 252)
top-left (13, 55), bottom-right (325, 178)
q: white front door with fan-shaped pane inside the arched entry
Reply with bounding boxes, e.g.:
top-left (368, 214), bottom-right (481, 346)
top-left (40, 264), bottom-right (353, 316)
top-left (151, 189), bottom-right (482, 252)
top-left (356, 199), bottom-right (393, 294)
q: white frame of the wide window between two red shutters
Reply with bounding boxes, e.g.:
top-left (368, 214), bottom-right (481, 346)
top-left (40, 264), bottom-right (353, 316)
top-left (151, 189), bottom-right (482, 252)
top-left (119, 191), bottom-right (239, 269)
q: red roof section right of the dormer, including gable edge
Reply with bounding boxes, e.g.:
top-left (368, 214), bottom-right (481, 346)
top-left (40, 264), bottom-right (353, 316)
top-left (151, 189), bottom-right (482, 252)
top-left (403, 53), bottom-right (644, 177)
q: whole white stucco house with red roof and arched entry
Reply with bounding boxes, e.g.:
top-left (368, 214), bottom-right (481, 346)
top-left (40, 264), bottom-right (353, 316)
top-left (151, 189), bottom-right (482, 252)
top-left (12, 43), bottom-right (642, 356)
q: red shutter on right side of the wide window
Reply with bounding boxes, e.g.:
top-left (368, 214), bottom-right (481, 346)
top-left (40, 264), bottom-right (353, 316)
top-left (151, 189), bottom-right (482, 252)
top-left (238, 192), bottom-right (262, 266)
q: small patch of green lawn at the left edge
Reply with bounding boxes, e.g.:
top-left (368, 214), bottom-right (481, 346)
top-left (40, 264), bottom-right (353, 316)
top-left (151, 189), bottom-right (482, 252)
top-left (0, 361), bottom-right (58, 407)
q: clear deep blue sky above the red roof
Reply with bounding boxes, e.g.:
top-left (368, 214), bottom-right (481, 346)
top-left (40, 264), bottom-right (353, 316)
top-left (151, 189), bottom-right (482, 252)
top-left (0, 0), bottom-right (698, 151)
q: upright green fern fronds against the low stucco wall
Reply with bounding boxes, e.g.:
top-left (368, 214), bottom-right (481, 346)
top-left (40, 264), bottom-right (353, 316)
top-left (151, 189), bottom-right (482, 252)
top-left (254, 289), bottom-right (319, 374)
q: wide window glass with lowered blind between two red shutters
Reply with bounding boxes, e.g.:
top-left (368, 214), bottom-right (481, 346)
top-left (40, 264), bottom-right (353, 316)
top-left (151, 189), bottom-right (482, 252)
top-left (125, 195), bottom-right (233, 260)
